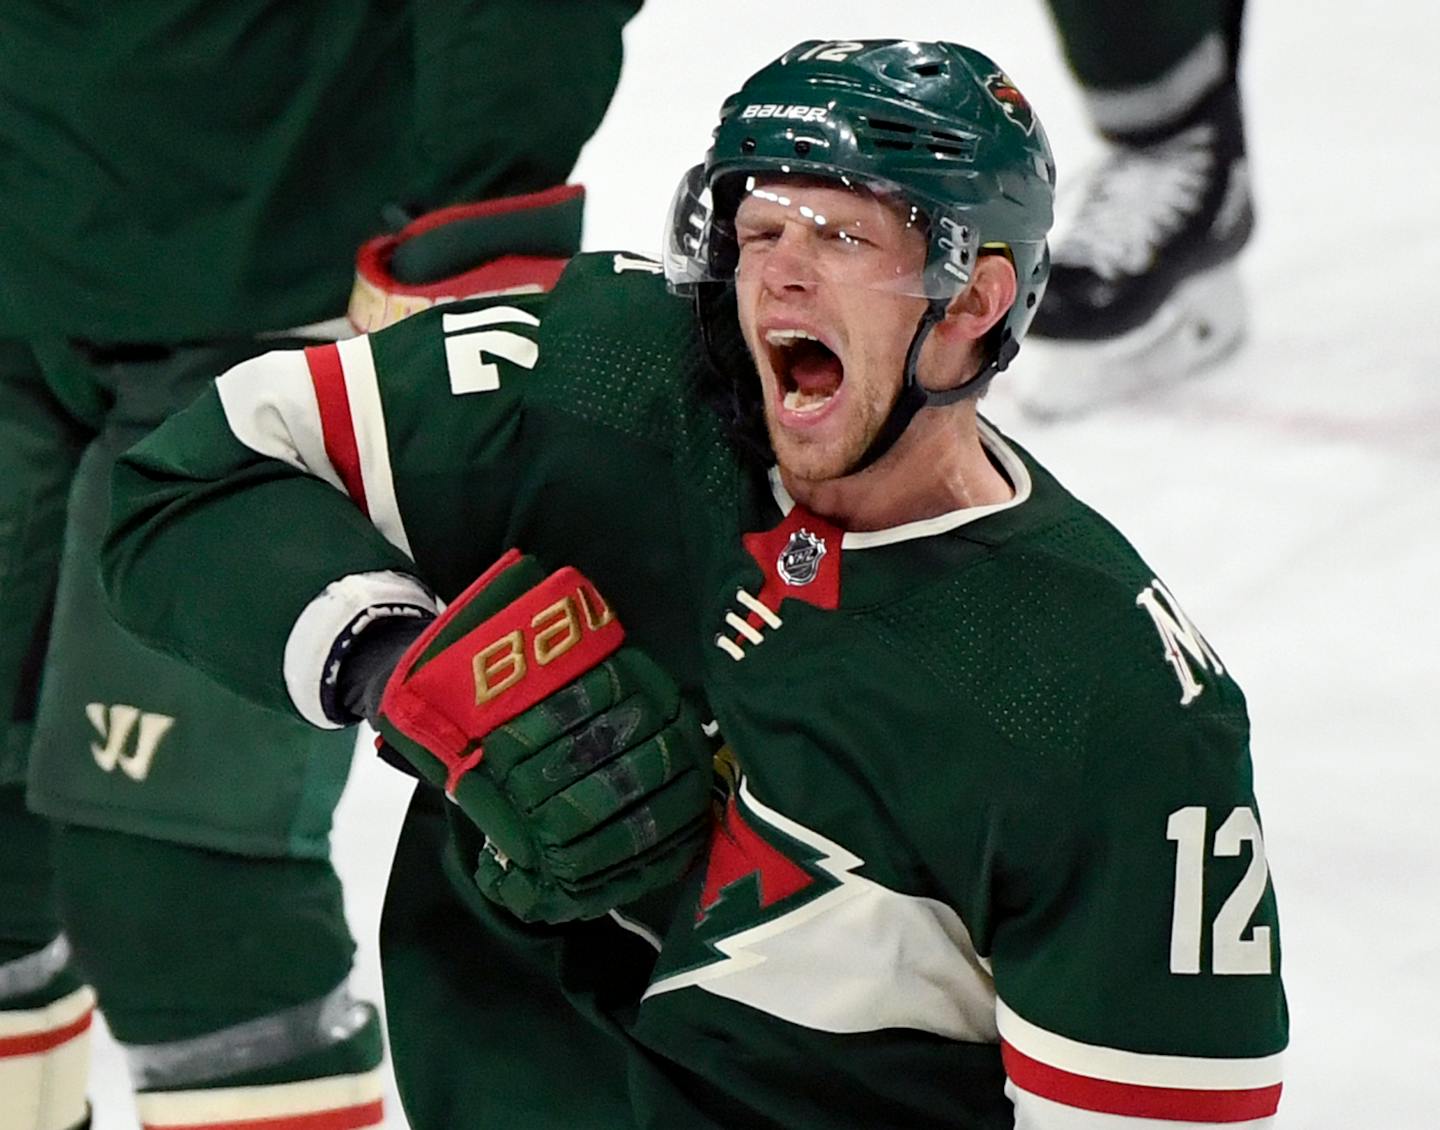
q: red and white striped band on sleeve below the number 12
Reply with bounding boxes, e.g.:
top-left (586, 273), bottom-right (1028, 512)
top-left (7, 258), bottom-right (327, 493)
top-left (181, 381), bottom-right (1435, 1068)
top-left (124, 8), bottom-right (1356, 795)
top-left (995, 1000), bottom-right (1282, 1130)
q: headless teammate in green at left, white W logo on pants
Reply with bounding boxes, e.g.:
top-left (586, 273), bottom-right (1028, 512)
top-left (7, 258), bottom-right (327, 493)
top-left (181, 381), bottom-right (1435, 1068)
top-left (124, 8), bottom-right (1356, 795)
top-left (0, 0), bottom-right (638, 1130)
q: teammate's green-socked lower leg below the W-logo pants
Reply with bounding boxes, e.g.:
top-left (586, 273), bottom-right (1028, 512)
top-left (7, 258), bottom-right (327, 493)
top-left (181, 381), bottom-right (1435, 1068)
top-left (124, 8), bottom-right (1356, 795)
top-left (56, 826), bottom-right (383, 1130)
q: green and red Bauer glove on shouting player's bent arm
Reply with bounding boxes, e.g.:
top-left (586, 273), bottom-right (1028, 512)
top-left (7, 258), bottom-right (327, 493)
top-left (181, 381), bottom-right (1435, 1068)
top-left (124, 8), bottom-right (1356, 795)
top-left (377, 550), bottom-right (710, 923)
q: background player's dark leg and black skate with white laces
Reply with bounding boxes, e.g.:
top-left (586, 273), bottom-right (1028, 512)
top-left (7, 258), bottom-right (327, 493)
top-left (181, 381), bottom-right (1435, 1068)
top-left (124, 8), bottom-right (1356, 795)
top-left (1017, 0), bottom-right (1254, 416)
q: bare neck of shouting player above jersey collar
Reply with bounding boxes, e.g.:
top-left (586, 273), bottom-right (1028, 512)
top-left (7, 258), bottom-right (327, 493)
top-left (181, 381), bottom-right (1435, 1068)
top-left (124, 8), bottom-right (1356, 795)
top-left (780, 403), bottom-right (1015, 531)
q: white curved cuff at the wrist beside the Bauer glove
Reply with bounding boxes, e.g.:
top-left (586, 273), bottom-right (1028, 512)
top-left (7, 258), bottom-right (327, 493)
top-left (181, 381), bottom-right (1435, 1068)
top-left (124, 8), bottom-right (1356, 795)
top-left (284, 570), bottom-right (439, 730)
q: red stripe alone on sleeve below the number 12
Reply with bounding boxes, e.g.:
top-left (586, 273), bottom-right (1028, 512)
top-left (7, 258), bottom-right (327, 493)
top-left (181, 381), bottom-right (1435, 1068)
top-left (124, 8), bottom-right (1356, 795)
top-left (1001, 1041), bottom-right (1280, 1123)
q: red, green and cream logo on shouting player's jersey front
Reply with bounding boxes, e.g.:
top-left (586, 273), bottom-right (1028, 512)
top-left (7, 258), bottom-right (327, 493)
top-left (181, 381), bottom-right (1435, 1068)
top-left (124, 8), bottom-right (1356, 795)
top-left (645, 779), bottom-right (996, 1042)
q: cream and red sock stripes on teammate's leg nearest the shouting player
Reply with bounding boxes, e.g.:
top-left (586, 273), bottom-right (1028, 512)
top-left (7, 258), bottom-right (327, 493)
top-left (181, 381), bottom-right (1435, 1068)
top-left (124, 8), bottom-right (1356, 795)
top-left (135, 1070), bottom-right (384, 1130)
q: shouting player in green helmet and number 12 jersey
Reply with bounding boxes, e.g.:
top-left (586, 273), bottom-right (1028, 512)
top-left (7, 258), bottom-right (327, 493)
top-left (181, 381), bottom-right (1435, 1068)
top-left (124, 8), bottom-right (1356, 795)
top-left (104, 40), bottom-right (1286, 1130)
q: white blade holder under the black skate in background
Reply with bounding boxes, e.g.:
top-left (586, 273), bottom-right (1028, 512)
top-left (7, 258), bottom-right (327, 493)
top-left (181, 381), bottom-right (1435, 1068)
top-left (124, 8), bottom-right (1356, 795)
top-left (1009, 263), bottom-right (1246, 420)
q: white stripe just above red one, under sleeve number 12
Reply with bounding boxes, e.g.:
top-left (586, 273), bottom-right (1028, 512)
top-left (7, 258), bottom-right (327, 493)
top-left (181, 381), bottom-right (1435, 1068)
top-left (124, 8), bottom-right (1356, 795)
top-left (995, 1000), bottom-right (1283, 1091)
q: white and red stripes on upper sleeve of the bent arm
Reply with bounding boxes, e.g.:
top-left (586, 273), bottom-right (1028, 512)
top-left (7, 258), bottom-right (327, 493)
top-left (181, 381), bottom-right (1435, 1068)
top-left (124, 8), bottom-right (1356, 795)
top-left (215, 337), bottom-right (412, 556)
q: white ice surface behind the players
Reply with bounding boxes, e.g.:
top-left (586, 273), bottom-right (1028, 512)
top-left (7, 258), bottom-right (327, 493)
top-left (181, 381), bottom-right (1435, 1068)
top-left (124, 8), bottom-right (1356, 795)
top-left (92, 0), bottom-right (1440, 1130)
